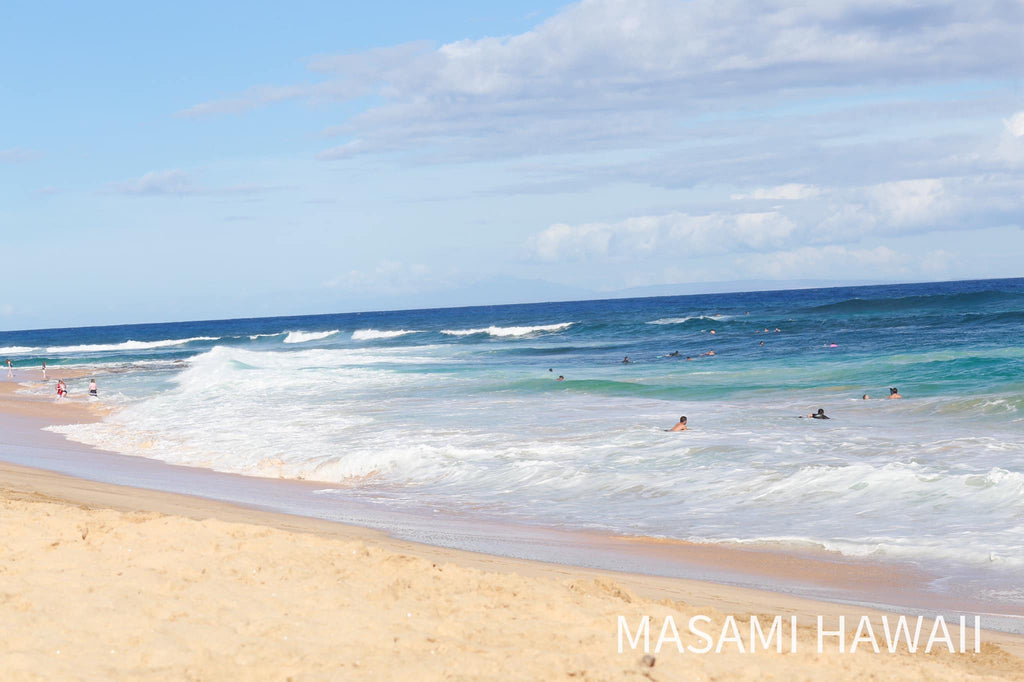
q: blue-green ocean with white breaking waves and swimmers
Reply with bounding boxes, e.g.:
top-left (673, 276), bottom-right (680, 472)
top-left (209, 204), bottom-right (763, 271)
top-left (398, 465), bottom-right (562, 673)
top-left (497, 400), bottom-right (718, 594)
top-left (0, 279), bottom-right (1024, 604)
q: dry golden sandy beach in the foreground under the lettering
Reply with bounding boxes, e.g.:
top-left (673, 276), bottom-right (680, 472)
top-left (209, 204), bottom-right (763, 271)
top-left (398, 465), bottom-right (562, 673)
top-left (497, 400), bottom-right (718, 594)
top-left (0, 383), bottom-right (1024, 680)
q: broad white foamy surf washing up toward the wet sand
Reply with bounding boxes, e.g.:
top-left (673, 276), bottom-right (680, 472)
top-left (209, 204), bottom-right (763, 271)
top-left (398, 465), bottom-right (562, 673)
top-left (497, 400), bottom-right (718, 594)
top-left (44, 342), bottom-right (1024, 572)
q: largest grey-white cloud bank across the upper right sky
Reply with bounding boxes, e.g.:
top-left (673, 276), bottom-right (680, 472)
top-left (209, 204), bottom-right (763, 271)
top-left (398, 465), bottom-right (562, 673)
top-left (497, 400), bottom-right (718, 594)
top-left (180, 0), bottom-right (1024, 164)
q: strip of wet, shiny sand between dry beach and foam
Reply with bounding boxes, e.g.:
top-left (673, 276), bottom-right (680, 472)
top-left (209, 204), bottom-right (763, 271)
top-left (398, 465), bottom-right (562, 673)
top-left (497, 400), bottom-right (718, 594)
top-left (6, 370), bottom-right (1024, 622)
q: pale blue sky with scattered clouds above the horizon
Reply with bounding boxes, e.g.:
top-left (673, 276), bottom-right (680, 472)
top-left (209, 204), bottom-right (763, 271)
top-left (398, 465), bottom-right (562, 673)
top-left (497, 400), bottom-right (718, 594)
top-left (0, 0), bottom-right (1024, 329)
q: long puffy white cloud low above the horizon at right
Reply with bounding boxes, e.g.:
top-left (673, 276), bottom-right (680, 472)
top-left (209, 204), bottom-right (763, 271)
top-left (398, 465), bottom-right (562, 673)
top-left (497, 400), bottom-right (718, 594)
top-left (528, 169), bottom-right (1024, 262)
